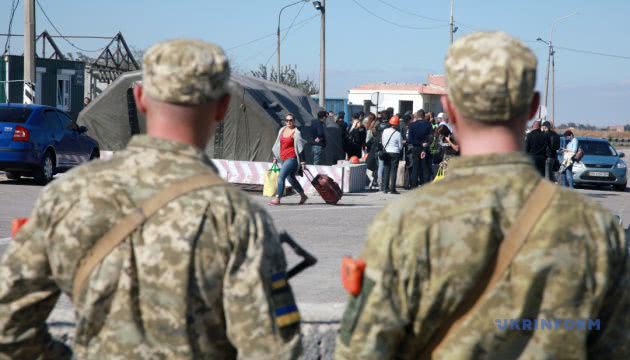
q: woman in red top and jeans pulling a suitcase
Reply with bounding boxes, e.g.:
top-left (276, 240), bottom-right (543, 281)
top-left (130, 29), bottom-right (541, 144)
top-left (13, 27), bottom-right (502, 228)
top-left (269, 113), bottom-right (308, 205)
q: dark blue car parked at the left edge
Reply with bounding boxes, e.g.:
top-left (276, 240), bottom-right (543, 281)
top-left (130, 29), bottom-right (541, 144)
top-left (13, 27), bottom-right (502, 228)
top-left (0, 104), bottom-right (100, 184)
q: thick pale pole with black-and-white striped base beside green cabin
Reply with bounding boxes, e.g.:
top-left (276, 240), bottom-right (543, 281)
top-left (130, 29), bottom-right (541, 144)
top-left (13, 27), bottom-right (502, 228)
top-left (23, 0), bottom-right (36, 104)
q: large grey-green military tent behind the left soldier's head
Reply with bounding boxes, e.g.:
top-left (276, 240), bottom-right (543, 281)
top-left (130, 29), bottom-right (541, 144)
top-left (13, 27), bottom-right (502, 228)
top-left (78, 71), bottom-right (344, 164)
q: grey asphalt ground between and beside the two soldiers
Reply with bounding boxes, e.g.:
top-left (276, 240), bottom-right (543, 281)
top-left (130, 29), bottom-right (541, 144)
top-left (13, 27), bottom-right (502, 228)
top-left (0, 167), bottom-right (630, 321)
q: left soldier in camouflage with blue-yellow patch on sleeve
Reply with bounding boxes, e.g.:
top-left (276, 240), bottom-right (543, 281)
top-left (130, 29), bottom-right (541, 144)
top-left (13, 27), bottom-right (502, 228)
top-left (0, 40), bottom-right (301, 359)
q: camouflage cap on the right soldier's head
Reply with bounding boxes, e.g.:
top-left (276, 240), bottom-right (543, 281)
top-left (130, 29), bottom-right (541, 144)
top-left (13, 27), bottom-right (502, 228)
top-left (445, 32), bottom-right (537, 122)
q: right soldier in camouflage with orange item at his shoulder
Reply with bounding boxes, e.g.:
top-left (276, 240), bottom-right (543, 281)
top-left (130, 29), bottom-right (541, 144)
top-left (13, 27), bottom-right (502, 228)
top-left (336, 33), bottom-right (630, 360)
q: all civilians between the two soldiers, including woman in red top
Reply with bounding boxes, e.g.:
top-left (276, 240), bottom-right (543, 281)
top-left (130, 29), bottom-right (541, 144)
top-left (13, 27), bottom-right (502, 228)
top-left (270, 108), bottom-right (459, 205)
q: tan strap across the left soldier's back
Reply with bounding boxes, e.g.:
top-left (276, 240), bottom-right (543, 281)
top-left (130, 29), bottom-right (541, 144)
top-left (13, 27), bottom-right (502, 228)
top-left (72, 173), bottom-right (225, 304)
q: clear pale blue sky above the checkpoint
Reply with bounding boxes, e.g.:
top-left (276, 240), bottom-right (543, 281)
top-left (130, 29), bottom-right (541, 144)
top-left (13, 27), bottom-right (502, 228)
top-left (0, 0), bottom-right (630, 125)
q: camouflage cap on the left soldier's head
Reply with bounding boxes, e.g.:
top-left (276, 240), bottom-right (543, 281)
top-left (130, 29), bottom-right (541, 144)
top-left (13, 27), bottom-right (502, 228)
top-left (142, 39), bottom-right (230, 105)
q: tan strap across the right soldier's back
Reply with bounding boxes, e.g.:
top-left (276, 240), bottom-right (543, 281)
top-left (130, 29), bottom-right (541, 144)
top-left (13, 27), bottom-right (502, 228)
top-left (420, 179), bottom-right (555, 359)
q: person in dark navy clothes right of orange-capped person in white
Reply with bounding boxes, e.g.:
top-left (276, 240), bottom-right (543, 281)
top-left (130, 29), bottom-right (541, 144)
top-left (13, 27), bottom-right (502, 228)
top-left (407, 110), bottom-right (433, 189)
